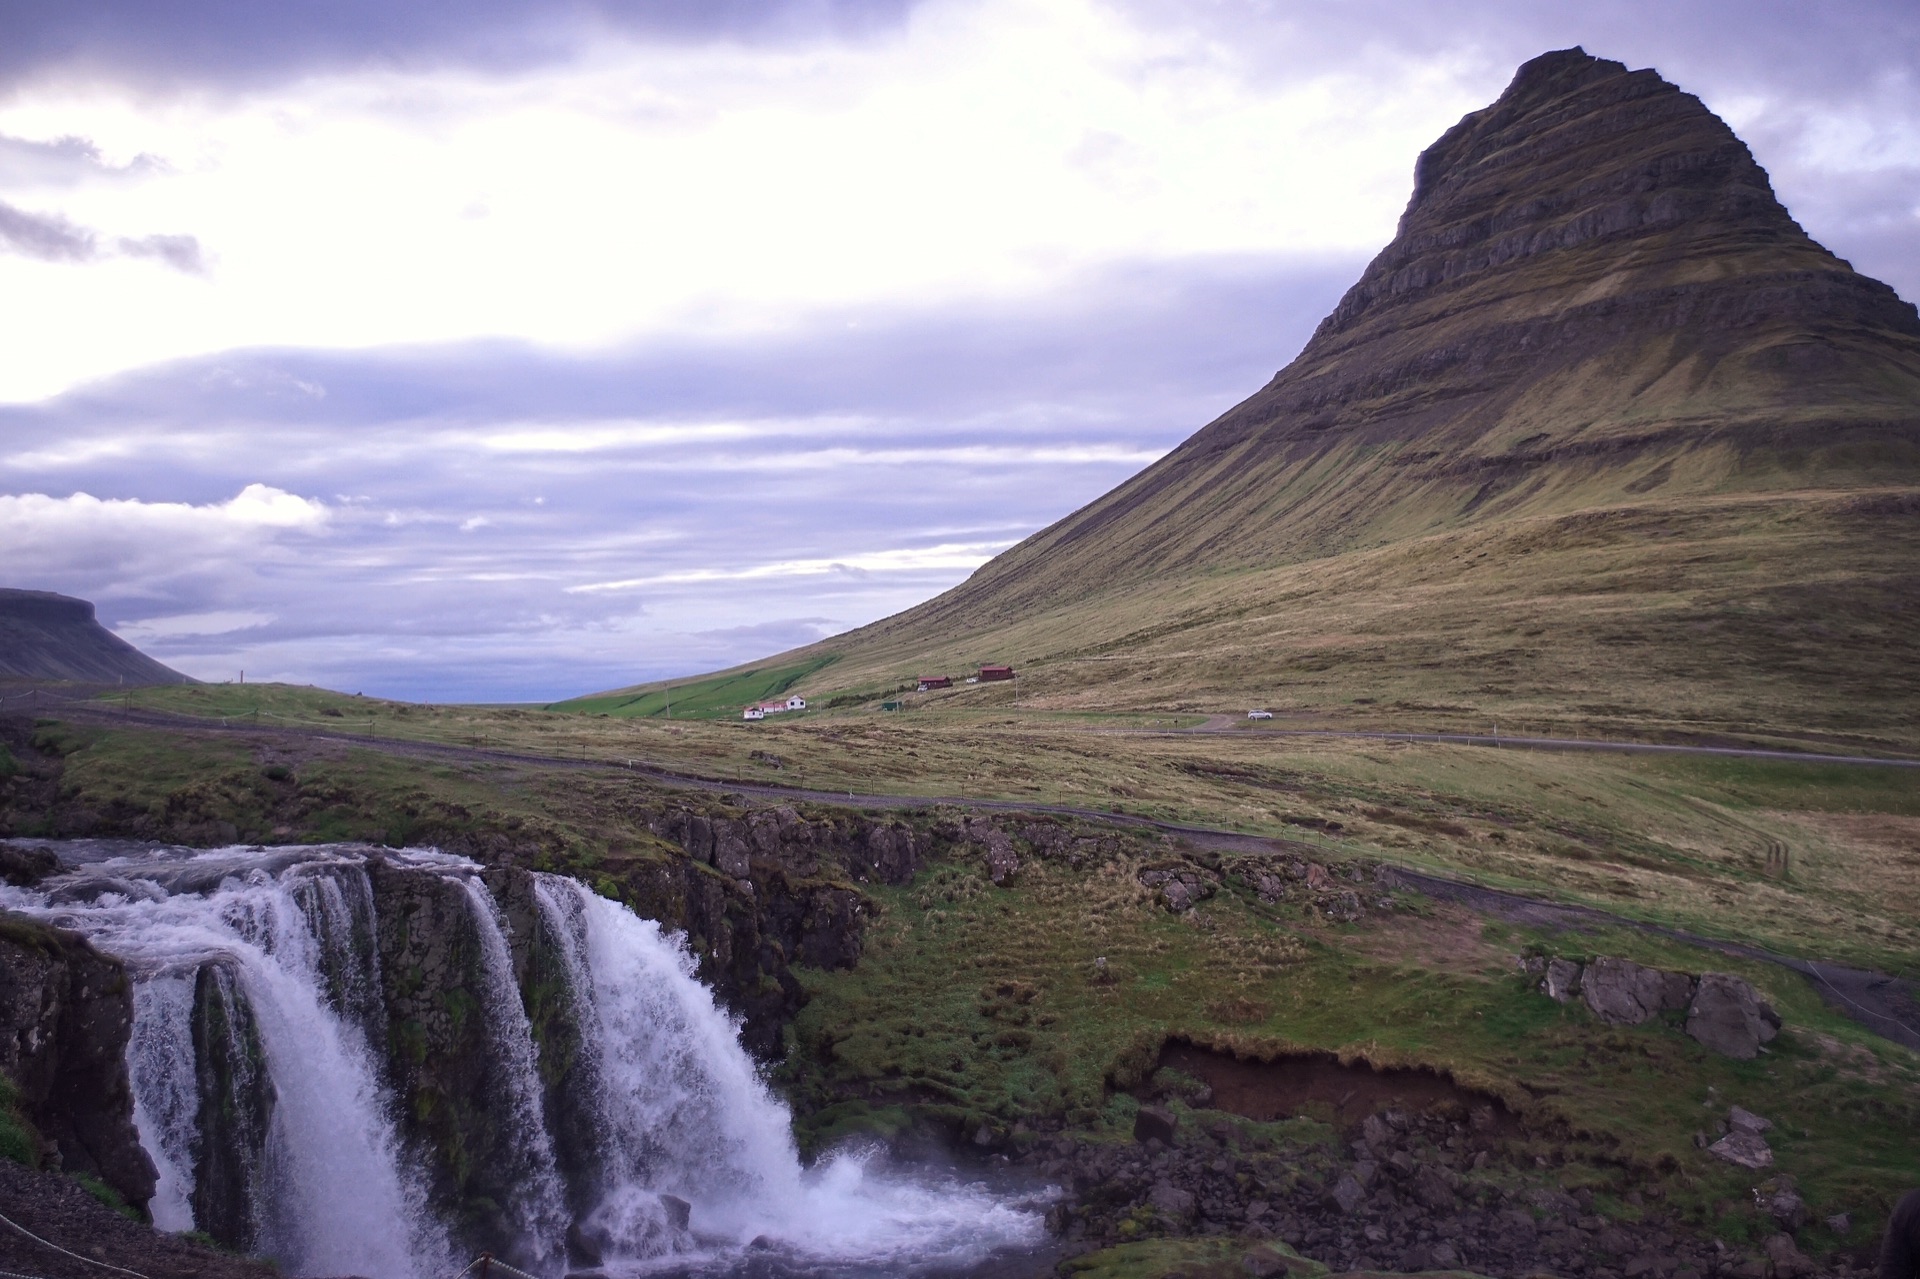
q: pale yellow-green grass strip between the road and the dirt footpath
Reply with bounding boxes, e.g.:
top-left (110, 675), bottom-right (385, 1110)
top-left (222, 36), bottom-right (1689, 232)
top-left (60, 686), bottom-right (1920, 974)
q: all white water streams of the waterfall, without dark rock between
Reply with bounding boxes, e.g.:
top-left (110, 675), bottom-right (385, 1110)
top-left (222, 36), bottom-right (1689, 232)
top-left (0, 847), bottom-right (1041, 1279)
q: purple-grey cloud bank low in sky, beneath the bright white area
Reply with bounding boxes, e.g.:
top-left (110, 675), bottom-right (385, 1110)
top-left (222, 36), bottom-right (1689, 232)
top-left (0, 249), bottom-right (1359, 699)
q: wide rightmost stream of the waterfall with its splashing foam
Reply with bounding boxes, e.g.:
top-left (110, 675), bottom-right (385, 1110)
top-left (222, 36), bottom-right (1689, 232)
top-left (540, 876), bottom-right (1041, 1269)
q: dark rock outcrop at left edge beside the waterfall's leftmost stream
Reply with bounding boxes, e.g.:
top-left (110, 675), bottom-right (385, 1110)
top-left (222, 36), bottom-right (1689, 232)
top-left (0, 914), bottom-right (156, 1208)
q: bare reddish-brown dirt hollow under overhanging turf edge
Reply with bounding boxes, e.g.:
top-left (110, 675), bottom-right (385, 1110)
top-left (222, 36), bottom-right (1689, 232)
top-left (1160, 1043), bottom-right (1519, 1131)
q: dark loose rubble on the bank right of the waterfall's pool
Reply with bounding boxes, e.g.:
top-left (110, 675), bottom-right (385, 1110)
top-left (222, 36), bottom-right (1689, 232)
top-left (1014, 1106), bottom-right (1866, 1279)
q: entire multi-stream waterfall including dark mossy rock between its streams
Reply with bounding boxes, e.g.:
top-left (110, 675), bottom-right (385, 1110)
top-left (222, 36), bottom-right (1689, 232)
top-left (0, 847), bottom-right (1041, 1279)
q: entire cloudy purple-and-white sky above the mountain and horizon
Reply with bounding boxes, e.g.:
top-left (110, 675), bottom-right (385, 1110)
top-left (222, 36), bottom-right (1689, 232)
top-left (0, 0), bottom-right (1920, 701)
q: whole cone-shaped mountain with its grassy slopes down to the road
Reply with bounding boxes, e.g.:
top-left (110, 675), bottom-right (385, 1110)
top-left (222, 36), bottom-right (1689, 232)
top-left (591, 50), bottom-right (1920, 741)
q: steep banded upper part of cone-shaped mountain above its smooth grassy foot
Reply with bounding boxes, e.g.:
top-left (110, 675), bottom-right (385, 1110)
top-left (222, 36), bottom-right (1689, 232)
top-left (879, 50), bottom-right (1920, 622)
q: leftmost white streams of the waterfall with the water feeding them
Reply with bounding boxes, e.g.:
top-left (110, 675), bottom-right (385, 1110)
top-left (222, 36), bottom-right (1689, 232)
top-left (8, 849), bottom-right (449, 1279)
